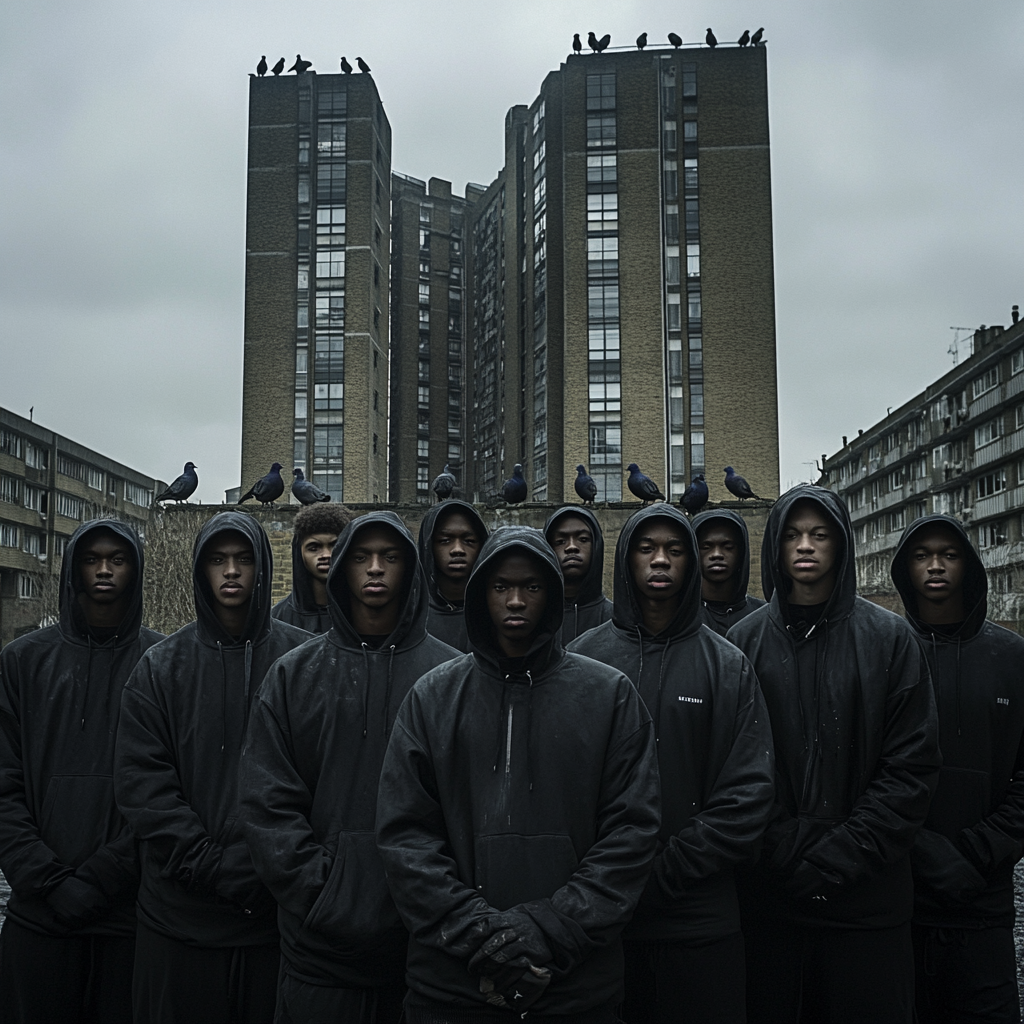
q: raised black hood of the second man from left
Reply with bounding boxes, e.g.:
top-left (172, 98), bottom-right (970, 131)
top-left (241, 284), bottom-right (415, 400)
top-left (193, 512), bottom-right (273, 647)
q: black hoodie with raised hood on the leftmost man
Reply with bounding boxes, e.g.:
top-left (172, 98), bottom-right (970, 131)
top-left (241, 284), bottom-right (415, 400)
top-left (0, 519), bottom-right (163, 936)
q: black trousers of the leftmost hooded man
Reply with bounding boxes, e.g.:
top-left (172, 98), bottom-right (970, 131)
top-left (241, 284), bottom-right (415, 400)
top-left (0, 918), bottom-right (135, 1024)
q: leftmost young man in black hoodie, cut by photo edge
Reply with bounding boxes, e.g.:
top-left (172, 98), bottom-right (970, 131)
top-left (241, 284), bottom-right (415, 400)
top-left (0, 519), bottom-right (162, 1024)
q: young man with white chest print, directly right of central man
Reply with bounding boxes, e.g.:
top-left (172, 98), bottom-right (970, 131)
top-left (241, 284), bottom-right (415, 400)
top-left (568, 505), bottom-right (773, 1024)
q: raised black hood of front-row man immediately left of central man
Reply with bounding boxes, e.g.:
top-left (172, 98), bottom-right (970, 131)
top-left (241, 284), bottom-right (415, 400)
top-left (327, 512), bottom-right (427, 650)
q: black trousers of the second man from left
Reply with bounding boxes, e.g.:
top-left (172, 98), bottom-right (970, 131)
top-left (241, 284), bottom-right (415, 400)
top-left (132, 922), bottom-right (281, 1024)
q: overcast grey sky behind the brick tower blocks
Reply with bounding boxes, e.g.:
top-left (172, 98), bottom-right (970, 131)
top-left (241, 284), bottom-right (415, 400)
top-left (0, 0), bottom-right (1024, 502)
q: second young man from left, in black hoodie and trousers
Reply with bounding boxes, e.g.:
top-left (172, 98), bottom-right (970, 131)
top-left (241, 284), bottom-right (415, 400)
top-left (115, 512), bottom-right (310, 1024)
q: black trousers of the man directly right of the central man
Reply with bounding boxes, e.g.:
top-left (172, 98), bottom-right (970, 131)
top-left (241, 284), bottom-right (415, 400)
top-left (623, 932), bottom-right (746, 1024)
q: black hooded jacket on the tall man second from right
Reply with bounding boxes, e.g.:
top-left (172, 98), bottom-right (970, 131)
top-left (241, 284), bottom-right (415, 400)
top-left (728, 484), bottom-right (941, 928)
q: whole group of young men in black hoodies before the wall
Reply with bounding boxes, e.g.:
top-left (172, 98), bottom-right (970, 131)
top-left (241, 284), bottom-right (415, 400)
top-left (0, 485), bottom-right (1024, 1024)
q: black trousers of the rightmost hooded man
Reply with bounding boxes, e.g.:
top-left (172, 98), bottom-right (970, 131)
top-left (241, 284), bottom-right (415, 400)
top-left (913, 925), bottom-right (1021, 1024)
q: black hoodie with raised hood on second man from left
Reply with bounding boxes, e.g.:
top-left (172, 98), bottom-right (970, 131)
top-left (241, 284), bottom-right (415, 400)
top-left (115, 512), bottom-right (309, 947)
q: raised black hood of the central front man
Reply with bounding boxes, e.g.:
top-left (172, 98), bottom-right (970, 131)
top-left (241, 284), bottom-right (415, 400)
top-left (466, 526), bottom-right (564, 675)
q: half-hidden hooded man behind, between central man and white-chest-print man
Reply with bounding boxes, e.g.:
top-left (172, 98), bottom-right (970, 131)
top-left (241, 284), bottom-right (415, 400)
top-left (544, 505), bottom-right (611, 647)
